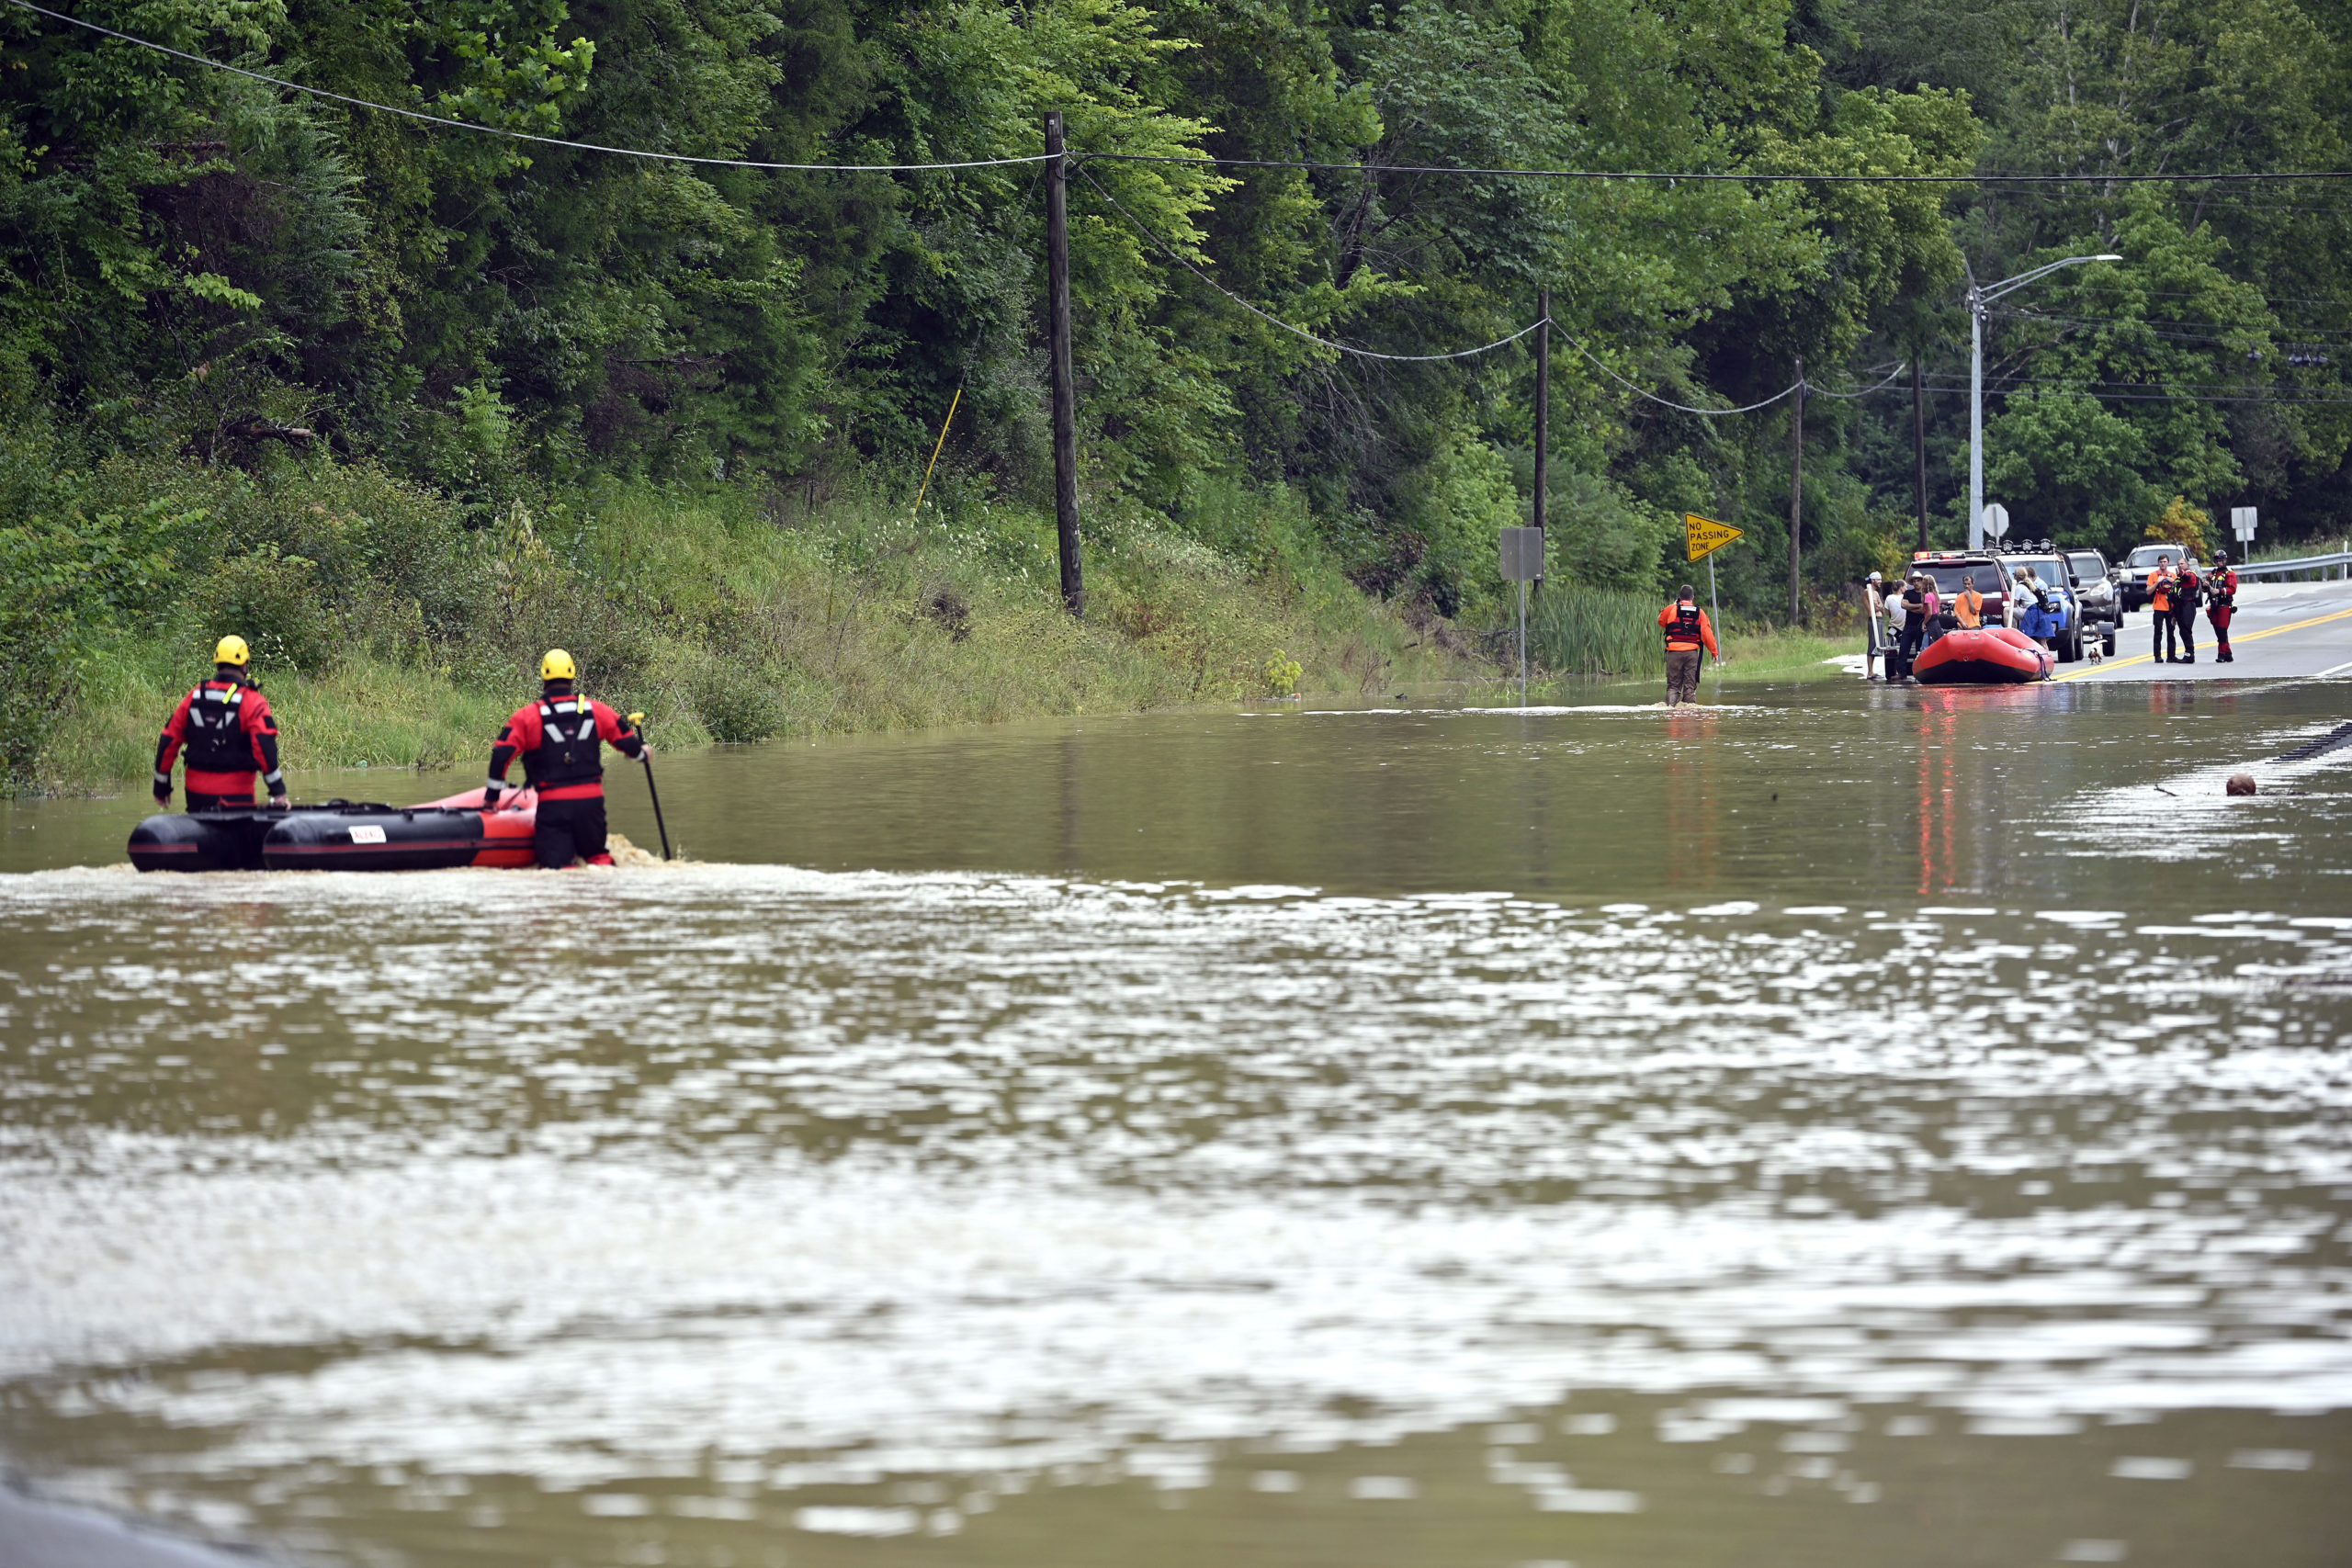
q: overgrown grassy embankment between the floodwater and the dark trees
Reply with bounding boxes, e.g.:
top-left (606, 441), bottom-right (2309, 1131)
top-left (12, 461), bottom-right (1477, 792)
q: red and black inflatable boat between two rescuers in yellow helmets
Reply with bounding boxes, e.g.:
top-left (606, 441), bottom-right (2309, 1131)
top-left (130, 790), bottom-right (538, 872)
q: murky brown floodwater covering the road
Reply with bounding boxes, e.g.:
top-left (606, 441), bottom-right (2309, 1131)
top-left (0, 682), bottom-right (2352, 1568)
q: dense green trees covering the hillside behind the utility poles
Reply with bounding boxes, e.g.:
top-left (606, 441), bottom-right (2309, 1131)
top-left (0, 0), bottom-right (2352, 691)
